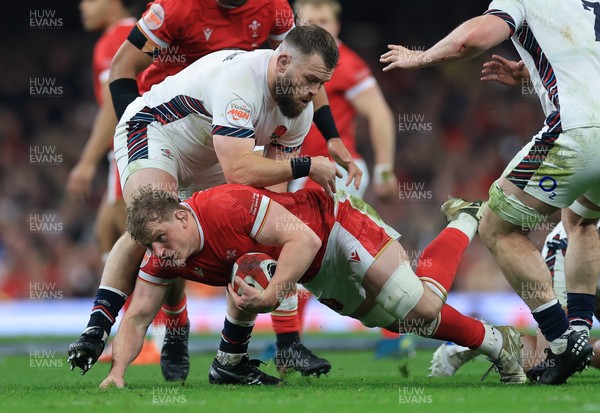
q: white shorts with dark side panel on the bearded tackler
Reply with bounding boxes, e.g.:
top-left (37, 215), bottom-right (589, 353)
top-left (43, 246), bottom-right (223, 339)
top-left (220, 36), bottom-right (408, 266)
top-left (114, 109), bottom-right (225, 199)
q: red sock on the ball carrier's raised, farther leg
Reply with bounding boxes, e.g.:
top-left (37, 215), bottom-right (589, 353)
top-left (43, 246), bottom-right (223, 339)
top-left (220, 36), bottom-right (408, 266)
top-left (416, 228), bottom-right (469, 301)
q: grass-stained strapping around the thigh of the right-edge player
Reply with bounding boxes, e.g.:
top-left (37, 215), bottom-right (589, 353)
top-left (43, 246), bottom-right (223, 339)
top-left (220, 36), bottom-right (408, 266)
top-left (486, 181), bottom-right (546, 232)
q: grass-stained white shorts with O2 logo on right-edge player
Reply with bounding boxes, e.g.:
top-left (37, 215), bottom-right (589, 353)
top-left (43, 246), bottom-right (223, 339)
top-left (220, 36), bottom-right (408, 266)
top-left (502, 127), bottom-right (600, 208)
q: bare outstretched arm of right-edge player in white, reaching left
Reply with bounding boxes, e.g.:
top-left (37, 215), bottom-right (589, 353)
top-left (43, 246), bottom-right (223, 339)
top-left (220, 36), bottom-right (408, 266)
top-left (379, 15), bottom-right (510, 71)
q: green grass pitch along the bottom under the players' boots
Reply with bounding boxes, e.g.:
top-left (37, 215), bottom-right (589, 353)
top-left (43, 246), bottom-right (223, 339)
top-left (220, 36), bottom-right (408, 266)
top-left (0, 338), bottom-right (600, 413)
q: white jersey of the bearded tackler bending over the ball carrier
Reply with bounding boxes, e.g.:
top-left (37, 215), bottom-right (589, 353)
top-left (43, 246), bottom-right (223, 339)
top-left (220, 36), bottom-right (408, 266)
top-left (121, 50), bottom-right (313, 154)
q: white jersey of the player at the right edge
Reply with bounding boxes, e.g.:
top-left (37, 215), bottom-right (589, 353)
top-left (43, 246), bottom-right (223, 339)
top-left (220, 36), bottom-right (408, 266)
top-left (485, 0), bottom-right (600, 132)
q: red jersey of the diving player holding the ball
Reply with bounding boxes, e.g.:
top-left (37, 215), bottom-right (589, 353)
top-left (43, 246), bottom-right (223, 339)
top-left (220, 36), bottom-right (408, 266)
top-left (139, 184), bottom-right (335, 286)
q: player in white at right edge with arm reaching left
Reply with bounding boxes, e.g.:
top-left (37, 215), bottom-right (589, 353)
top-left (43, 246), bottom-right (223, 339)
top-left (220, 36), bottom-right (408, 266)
top-left (380, 0), bottom-right (600, 384)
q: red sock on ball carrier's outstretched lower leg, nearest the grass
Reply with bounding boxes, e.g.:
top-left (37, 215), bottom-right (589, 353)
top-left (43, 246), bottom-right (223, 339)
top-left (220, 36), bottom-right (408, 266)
top-left (431, 304), bottom-right (485, 349)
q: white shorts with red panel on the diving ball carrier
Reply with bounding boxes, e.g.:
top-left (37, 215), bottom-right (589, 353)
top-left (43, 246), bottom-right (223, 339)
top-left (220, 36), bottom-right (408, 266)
top-left (303, 192), bottom-right (423, 327)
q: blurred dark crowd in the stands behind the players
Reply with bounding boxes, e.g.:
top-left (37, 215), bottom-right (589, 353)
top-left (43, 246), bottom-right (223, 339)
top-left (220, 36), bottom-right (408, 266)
top-left (0, 0), bottom-right (549, 299)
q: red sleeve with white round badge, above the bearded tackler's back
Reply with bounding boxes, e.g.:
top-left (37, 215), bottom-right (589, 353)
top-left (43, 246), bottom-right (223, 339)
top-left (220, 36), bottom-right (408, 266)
top-left (137, 0), bottom-right (190, 48)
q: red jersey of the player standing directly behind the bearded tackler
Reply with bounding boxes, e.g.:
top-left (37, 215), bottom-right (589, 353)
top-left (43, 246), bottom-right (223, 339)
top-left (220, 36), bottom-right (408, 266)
top-left (137, 0), bottom-right (294, 93)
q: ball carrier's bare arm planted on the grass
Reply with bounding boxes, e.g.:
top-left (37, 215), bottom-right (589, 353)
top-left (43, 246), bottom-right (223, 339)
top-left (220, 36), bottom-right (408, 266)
top-left (100, 280), bottom-right (167, 387)
